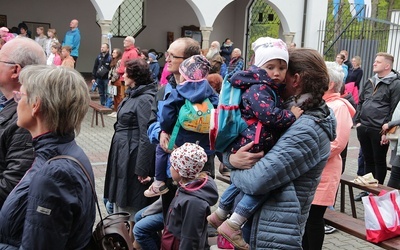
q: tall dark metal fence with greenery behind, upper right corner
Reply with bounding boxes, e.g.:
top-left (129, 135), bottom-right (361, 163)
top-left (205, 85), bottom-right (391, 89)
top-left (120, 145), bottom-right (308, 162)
top-left (318, 3), bottom-right (400, 81)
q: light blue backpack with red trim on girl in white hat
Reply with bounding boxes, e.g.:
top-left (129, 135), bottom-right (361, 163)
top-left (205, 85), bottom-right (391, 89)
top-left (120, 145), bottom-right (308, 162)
top-left (210, 75), bottom-right (248, 152)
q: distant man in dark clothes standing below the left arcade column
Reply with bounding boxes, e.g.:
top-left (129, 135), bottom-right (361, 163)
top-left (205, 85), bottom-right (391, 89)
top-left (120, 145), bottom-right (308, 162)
top-left (92, 43), bottom-right (111, 106)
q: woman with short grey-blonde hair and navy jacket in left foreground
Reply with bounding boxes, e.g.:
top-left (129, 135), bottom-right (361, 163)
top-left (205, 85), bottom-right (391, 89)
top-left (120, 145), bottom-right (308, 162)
top-left (0, 66), bottom-right (96, 249)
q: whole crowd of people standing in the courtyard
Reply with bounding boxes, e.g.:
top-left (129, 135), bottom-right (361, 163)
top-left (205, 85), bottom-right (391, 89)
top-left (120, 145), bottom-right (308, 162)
top-left (0, 19), bottom-right (400, 250)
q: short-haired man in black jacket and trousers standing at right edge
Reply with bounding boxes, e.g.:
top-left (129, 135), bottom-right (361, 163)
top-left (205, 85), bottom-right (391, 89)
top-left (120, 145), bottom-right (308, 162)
top-left (355, 52), bottom-right (400, 201)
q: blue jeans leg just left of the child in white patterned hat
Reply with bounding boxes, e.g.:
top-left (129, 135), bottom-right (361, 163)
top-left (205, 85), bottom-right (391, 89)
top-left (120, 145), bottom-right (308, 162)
top-left (133, 207), bottom-right (164, 250)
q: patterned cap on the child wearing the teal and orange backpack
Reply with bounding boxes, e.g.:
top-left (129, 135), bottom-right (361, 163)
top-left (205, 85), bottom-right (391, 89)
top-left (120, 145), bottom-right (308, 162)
top-left (179, 55), bottom-right (211, 82)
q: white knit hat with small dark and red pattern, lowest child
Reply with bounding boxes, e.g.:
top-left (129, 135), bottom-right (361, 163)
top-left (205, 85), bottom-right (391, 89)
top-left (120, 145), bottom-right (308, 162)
top-left (170, 142), bottom-right (207, 179)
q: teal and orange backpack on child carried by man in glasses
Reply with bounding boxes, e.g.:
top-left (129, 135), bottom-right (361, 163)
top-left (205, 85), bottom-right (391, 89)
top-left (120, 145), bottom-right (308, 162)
top-left (168, 98), bottom-right (214, 150)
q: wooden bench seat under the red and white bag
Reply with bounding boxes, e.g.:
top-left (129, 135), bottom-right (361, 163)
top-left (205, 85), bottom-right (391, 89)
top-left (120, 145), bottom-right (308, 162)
top-left (324, 209), bottom-right (400, 250)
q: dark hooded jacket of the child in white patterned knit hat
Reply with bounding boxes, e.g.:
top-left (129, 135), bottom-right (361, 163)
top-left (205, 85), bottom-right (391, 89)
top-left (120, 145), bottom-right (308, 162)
top-left (161, 176), bottom-right (218, 250)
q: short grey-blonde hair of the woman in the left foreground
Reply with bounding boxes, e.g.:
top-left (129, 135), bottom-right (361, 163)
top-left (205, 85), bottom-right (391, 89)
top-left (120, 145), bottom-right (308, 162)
top-left (19, 65), bottom-right (90, 135)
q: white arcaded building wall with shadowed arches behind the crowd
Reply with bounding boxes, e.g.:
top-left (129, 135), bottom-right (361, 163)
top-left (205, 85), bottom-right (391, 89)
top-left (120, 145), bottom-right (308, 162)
top-left (0, 0), bottom-right (327, 72)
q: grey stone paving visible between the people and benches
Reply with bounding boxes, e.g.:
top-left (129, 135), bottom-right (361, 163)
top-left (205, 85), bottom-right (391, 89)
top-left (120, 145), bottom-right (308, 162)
top-left (76, 108), bottom-right (390, 250)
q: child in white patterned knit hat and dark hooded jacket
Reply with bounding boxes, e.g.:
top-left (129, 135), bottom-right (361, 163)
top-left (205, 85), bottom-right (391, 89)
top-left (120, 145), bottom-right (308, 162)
top-left (161, 143), bottom-right (218, 250)
